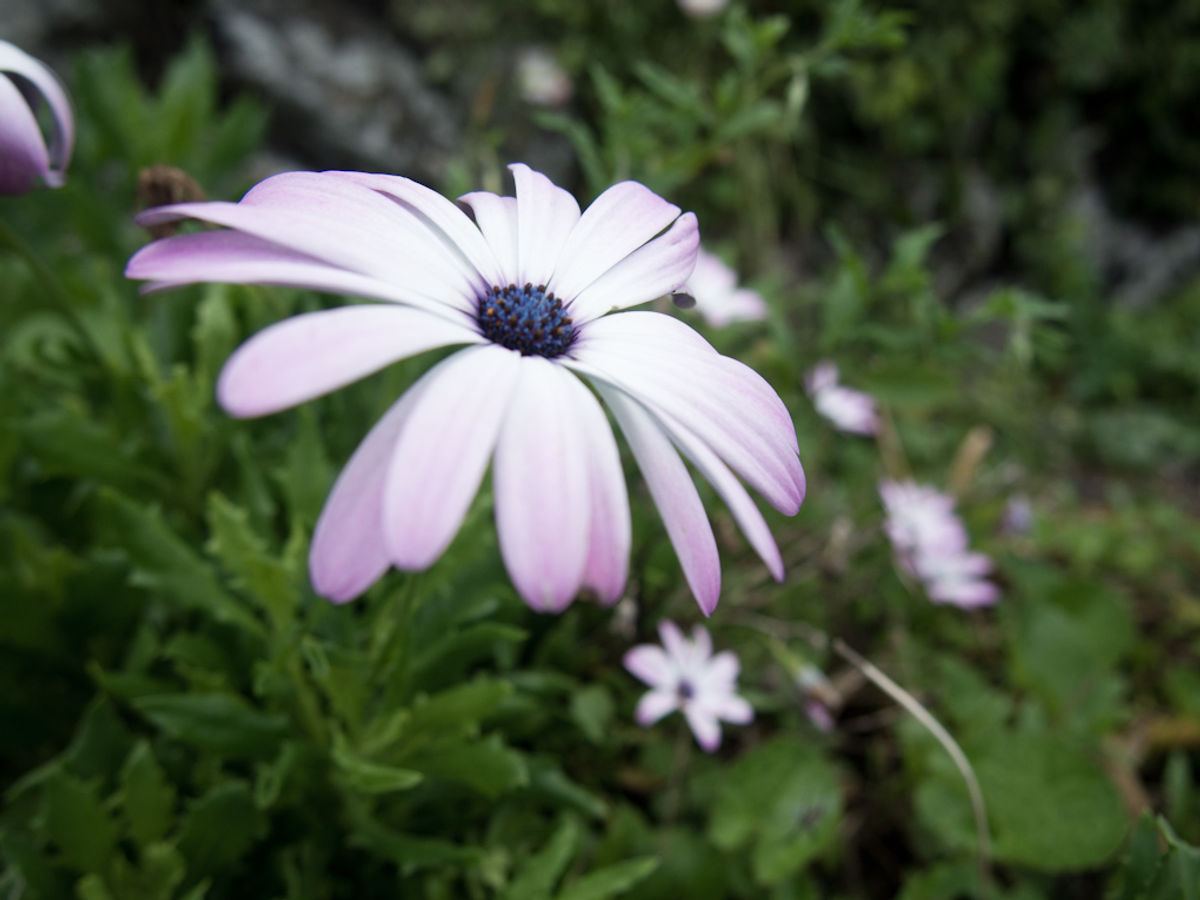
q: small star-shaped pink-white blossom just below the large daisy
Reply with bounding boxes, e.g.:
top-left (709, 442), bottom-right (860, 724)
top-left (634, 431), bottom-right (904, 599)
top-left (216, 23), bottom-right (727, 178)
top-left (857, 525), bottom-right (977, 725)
top-left (625, 622), bottom-right (754, 752)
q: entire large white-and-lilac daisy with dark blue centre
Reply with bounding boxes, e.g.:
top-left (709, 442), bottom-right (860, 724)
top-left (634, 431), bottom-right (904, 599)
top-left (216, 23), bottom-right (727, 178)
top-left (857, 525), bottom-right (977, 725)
top-left (126, 163), bottom-right (804, 614)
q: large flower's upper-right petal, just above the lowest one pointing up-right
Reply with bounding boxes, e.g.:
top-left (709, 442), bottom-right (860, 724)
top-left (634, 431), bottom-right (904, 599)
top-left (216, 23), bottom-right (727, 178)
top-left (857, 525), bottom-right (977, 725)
top-left (550, 181), bottom-right (679, 299)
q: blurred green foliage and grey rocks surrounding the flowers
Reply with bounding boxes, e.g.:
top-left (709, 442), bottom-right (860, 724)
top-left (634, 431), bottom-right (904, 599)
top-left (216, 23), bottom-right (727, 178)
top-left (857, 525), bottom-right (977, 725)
top-left (0, 0), bottom-right (1200, 900)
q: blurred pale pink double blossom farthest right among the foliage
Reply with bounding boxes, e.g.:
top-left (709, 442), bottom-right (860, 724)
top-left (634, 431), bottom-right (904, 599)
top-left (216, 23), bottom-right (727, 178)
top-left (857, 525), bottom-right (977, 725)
top-left (880, 481), bottom-right (1000, 608)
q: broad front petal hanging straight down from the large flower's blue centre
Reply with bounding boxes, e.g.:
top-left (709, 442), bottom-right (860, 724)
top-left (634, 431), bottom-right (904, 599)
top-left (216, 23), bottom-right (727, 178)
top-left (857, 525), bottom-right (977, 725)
top-left (492, 356), bottom-right (592, 612)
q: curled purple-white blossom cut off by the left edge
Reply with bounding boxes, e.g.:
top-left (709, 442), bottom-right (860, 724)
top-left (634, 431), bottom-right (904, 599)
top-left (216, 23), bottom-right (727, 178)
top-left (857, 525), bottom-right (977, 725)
top-left (0, 41), bottom-right (74, 196)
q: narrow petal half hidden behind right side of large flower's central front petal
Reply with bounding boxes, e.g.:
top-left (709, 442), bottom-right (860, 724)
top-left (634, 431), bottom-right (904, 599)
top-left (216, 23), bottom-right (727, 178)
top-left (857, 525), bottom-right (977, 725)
top-left (569, 376), bottom-right (630, 604)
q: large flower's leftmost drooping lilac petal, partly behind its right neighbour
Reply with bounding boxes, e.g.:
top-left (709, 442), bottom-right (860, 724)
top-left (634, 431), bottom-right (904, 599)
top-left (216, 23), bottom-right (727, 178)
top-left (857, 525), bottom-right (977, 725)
top-left (308, 389), bottom-right (416, 602)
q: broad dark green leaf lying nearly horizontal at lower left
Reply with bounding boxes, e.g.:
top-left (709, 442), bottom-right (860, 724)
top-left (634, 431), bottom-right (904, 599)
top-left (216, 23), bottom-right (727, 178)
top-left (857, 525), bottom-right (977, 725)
top-left (133, 694), bottom-right (287, 758)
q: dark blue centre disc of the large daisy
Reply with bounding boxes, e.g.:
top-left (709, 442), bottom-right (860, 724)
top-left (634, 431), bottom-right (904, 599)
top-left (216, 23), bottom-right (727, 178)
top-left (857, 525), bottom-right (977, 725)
top-left (475, 284), bottom-right (575, 359)
